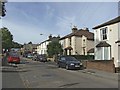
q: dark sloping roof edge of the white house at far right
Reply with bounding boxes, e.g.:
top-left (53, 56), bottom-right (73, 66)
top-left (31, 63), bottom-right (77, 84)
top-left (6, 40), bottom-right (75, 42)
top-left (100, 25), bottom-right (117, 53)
top-left (93, 16), bottom-right (120, 29)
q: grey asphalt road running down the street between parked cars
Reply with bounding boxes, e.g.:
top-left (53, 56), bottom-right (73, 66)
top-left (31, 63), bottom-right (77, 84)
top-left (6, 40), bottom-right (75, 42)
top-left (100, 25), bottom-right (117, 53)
top-left (3, 59), bottom-right (118, 88)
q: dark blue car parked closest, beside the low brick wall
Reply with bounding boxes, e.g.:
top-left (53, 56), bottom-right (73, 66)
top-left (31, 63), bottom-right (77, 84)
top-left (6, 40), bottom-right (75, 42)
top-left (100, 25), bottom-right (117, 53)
top-left (57, 56), bottom-right (82, 70)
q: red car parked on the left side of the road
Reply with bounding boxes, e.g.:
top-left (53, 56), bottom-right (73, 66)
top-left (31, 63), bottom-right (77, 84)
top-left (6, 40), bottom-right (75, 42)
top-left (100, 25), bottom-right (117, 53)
top-left (7, 52), bottom-right (20, 64)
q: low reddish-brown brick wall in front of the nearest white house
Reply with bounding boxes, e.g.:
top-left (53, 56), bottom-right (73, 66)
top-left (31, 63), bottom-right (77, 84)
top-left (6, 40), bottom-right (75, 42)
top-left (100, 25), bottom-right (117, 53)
top-left (85, 60), bottom-right (115, 73)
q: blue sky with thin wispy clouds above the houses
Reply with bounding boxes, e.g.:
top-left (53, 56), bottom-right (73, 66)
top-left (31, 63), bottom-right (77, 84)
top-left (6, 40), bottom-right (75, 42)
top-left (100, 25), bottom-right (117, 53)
top-left (2, 0), bottom-right (118, 44)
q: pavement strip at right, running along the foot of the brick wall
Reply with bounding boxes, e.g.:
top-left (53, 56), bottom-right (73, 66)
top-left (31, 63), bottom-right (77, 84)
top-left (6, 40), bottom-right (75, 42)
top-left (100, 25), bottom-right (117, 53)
top-left (82, 69), bottom-right (120, 80)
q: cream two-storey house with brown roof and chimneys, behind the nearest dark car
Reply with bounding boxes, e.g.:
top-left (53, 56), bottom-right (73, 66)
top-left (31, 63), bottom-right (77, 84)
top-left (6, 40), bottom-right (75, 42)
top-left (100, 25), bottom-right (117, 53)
top-left (60, 27), bottom-right (94, 55)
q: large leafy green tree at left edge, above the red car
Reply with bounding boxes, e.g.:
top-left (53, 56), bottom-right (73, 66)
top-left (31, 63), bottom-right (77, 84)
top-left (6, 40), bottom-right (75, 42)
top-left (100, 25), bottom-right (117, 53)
top-left (0, 27), bottom-right (13, 49)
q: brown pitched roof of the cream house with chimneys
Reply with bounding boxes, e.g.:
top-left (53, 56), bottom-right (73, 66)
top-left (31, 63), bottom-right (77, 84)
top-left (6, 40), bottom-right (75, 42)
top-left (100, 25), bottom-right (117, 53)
top-left (60, 29), bottom-right (94, 40)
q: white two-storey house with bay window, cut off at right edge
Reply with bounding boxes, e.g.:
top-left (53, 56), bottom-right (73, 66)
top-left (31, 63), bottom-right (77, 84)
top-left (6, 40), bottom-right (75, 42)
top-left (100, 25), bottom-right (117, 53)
top-left (93, 16), bottom-right (120, 67)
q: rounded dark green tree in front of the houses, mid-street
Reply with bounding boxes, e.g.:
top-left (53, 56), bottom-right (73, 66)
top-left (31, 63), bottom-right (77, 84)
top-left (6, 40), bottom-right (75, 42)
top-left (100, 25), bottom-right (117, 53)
top-left (47, 40), bottom-right (63, 58)
